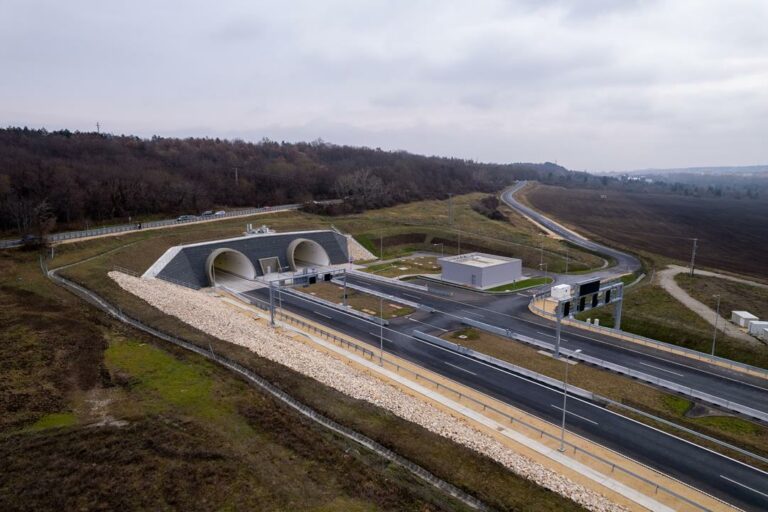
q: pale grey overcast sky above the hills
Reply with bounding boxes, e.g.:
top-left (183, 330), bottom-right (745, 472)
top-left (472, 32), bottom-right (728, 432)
top-left (0, 0), bottom-right (768, 171)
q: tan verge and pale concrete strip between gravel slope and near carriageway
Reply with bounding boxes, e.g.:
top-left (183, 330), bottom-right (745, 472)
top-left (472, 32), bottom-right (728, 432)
top-left (219, 292), bottom-right (734, 510)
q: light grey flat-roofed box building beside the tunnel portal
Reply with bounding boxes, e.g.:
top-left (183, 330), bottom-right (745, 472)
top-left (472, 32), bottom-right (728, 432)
top-left (438, 252), bottom-right (523, 290)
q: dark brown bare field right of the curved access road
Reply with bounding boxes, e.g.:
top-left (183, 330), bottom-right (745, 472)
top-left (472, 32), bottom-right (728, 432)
top-left (525, 185), bottom-right (768, 280)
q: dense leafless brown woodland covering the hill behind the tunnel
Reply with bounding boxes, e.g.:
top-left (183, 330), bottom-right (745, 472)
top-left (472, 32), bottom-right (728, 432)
top-left (0, 128), bottom-right (572, 233)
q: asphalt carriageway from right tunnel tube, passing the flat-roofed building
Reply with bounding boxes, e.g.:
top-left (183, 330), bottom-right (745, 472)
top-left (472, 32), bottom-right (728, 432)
top-left (347, 274), bottom-right (768, 413)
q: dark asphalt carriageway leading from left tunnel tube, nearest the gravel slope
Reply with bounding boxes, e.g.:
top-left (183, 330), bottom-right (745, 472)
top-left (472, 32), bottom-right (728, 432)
top-left (245, 288), bottom-right (768, 510)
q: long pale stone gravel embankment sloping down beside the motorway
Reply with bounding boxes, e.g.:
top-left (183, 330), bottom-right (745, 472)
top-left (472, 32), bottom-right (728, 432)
top-left (109, 272), bottom-right (625, 512)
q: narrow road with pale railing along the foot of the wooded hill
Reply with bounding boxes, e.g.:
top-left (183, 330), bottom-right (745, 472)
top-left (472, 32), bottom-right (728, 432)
top-left (0, 199), bottom-right (341, 249)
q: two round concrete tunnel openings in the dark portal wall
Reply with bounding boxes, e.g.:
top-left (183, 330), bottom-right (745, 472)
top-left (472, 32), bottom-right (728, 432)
top-left (206, 238), bottom-right (331, 284)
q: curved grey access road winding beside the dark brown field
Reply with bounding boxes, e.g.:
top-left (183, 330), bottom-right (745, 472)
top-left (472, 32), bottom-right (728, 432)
top-left (501, 181), bottom-right (641, 280)
